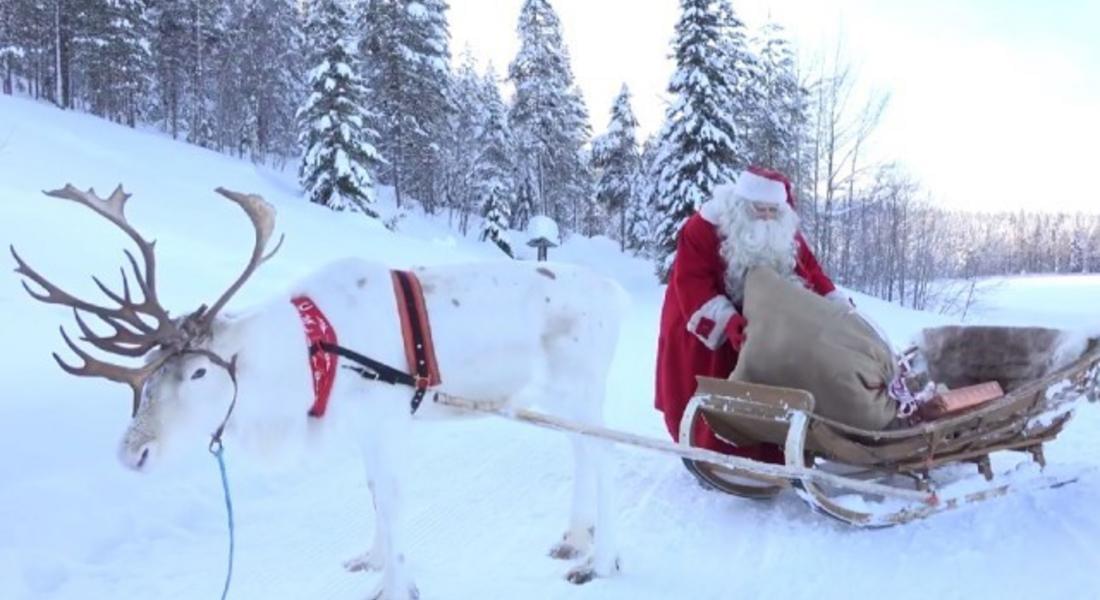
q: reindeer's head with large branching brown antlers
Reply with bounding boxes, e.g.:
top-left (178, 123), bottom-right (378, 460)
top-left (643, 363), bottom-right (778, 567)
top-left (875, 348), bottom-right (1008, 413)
top-left (11, 185), bottom-right (283, 469)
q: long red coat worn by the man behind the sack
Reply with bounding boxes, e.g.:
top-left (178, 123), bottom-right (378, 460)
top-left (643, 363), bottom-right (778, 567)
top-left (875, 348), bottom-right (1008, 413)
top-left (656, 212), bottom-right (836, 462)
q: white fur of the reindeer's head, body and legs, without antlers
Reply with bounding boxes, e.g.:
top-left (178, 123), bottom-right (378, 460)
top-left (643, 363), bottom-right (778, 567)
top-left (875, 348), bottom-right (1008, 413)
top-left (120, 255), bottom-right (626, 598)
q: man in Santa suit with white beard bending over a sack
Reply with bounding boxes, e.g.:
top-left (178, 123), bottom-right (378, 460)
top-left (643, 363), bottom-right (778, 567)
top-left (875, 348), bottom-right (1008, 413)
top-left (656, 167), bottom-right (849, 482)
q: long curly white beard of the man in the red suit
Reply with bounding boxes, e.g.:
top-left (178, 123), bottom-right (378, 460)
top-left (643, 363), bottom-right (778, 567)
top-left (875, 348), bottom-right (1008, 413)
top-left (717, 200), bottom-right (805, 306)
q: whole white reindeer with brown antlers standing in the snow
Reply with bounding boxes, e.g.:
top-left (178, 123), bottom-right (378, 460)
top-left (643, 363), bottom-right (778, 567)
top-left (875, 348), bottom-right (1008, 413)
top-left (12, 186), bottom-right (625, 598)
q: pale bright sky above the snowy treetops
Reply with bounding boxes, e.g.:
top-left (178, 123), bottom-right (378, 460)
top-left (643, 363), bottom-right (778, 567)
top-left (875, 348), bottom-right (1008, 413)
top-left (450, 0), bottom-right (1100, 212)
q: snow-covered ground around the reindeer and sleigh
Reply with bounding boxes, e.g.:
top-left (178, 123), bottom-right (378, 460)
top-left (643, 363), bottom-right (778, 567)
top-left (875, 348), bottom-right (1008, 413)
top-left (0, 97), bottom-right (1100, 600)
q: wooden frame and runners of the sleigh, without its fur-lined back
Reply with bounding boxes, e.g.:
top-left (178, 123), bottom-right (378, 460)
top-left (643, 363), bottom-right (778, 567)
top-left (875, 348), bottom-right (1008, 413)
top-left (680, 340), bottom-right (1100, 527)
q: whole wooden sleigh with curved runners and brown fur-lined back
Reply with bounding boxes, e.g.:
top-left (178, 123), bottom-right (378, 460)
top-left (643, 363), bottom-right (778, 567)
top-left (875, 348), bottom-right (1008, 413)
top-left (681, 327), bottom-right (1100, 526)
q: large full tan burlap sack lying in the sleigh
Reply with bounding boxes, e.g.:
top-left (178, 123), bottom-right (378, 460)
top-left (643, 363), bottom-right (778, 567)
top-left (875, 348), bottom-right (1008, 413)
top-left (730, 269), bottom-right (898, 429)
